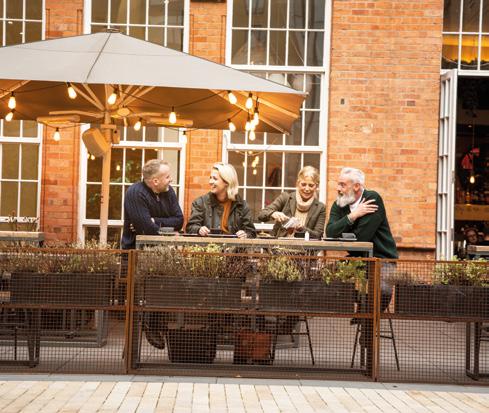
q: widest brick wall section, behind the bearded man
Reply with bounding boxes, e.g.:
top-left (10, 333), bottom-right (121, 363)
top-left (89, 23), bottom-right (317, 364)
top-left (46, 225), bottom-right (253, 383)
top-left (328, 0), bottom-right (443, 255)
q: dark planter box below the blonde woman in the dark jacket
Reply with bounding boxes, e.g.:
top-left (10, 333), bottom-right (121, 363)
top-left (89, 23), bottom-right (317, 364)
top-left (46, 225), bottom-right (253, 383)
top-left (137, 276), bottom-right (243, 309)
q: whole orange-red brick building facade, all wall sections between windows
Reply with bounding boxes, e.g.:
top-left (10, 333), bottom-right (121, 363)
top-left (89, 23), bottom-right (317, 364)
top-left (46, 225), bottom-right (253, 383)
top-left (0, 0), bottom-right (458, 257)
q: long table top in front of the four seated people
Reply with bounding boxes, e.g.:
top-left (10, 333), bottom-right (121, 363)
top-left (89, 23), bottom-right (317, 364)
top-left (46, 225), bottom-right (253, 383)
top-left (136, 235), bottom-right (373, 256)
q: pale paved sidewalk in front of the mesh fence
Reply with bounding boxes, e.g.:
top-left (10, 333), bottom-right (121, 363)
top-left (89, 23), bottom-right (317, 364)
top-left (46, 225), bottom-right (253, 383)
top-left (0, 374), bottom-right (489, 413)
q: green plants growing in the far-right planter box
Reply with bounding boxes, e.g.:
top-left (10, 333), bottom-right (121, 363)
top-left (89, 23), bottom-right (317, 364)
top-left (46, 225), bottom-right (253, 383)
top-left (433, 257), bottom-right (489, 287)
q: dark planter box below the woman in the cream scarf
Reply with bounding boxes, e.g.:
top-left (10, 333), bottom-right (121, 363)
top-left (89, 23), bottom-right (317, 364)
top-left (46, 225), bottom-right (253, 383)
top-left (258, 281), bottom-right (356, 313)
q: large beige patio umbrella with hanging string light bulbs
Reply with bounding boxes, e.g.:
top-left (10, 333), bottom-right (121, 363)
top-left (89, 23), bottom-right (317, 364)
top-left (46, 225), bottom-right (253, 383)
top-left (0, 32), bottom-right (305, 242)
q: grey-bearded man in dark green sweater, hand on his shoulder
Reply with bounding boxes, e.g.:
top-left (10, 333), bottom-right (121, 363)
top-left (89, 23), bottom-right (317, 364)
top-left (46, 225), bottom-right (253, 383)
top-left (326, 168), bottom-right (399, 311)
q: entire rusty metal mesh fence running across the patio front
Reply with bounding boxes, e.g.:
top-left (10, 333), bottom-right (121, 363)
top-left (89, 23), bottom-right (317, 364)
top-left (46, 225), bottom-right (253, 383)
top-left (0, 245), bottom-right (489, 384)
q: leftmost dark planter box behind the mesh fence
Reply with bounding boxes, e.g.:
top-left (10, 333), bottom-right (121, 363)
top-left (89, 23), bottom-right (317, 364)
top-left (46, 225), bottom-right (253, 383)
top-left (10, 272), bottom-right (114, 307)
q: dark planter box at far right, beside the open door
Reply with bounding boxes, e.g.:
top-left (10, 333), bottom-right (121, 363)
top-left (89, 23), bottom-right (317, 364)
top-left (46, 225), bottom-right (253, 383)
top-left (395, 285), bottom-right (489, 318)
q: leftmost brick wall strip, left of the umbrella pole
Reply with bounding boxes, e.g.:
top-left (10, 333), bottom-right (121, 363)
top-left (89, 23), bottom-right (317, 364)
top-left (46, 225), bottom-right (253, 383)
top-left (40, 0), bottom-right (83, 242)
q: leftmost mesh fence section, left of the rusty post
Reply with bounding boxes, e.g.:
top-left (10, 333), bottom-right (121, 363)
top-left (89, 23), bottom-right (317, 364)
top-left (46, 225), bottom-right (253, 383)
top-left (0, 248), bottom-right (127, 373)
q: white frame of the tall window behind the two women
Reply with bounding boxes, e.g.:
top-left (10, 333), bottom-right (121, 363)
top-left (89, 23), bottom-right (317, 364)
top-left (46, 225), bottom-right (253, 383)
top-left (222, 0), bottom-right (332, 206)
